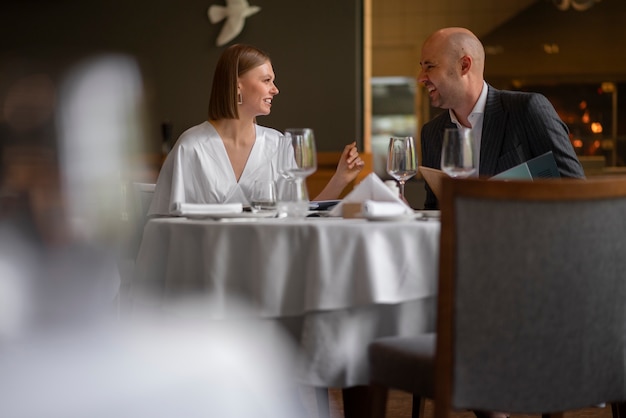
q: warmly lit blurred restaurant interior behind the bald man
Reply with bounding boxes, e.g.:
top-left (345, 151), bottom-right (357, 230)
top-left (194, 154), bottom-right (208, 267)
top-left (372, 0), bottom-right (626, 205)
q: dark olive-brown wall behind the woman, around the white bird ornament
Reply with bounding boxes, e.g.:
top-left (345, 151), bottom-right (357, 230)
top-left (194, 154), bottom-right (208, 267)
top-left (0, 0), bottom-right (363, 151)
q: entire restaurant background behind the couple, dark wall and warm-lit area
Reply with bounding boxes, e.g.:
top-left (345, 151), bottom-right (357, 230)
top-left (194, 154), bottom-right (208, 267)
top-left (0, 0), bottom-right (626, 207)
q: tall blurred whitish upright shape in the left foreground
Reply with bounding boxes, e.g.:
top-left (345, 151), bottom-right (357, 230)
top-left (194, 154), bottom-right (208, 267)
top-left (58, 55), bottom-right (144, 242)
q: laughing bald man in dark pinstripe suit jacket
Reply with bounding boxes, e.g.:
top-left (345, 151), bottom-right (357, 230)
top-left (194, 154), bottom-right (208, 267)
top-left (418, 28), bottom-right (585, 209)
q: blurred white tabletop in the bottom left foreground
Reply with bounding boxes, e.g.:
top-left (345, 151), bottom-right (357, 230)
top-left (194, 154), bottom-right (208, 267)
top-left (0, 299), bottom-right (307, 418)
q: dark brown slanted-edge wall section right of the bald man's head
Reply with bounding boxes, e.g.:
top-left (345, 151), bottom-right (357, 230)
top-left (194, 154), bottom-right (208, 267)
top-left (482, 0), bottom-right (626, 85)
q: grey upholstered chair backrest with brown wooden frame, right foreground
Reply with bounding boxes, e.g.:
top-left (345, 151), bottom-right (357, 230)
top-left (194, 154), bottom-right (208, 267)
top-left (435, 178), bottom-right (626, 417)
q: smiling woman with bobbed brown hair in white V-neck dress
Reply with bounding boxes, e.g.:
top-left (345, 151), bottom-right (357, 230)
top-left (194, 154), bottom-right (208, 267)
top-left (148, 44), bottom-right (364, 215)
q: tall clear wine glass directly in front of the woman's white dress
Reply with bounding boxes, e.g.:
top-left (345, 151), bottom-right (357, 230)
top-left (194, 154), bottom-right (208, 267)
top-left (278, 128), bottom-right (317, 217)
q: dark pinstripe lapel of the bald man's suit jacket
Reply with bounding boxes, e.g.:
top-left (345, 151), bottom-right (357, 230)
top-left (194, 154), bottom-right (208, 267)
top-left (479, 86), bottom-right (508, 175)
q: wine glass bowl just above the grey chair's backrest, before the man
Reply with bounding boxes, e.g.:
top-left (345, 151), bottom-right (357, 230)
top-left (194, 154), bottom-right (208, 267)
top-left (441, 128), bottom-right (476, 178)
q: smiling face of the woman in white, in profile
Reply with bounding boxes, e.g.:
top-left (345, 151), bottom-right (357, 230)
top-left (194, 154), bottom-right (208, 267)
top-left (238, 61), bottom-right (278, 117)
